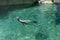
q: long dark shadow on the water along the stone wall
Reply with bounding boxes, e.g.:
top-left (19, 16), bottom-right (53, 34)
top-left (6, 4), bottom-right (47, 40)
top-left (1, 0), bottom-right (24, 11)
top-left (0, 4), bottom-right (36, 19)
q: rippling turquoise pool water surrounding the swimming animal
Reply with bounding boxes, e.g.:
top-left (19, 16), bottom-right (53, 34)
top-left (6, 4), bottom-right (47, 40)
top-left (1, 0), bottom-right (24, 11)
top-left (0, 4), bottom-right (56, 40)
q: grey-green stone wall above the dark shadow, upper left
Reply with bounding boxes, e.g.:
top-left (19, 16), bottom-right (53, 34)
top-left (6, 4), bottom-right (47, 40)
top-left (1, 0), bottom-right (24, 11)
top-left (0, 0), bottom-right (38, 5)
